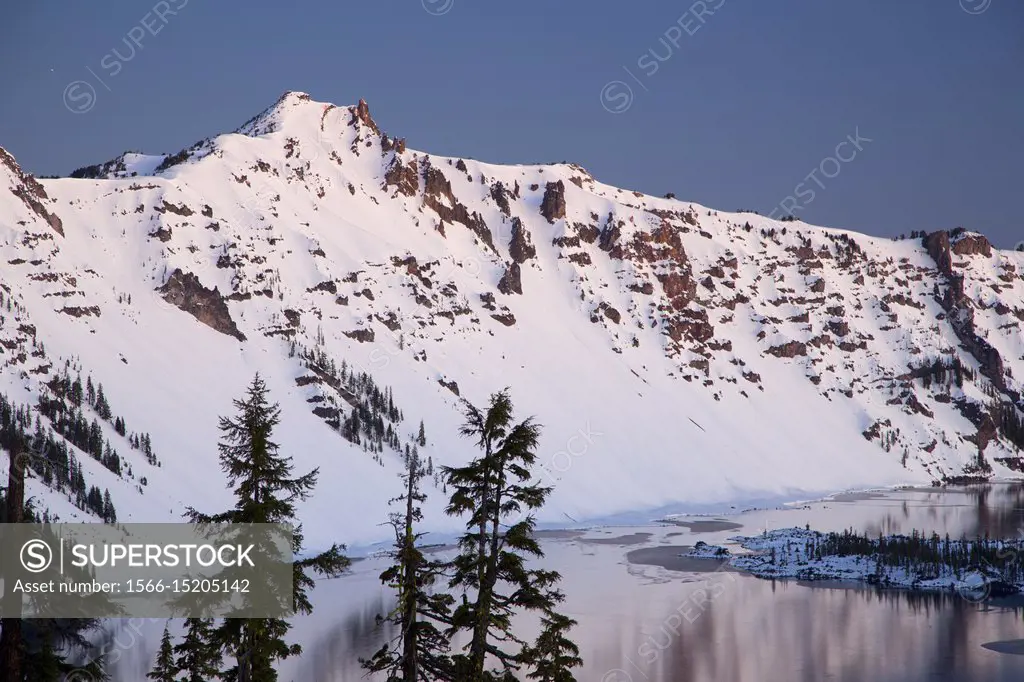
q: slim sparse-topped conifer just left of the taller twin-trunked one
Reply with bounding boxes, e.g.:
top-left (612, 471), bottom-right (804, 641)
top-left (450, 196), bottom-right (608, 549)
top-left (361, 448), bottom-right (455, 682)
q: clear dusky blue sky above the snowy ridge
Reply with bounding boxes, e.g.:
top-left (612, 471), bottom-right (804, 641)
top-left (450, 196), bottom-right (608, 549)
top-left (0, 0), bottom-right (1024, 246)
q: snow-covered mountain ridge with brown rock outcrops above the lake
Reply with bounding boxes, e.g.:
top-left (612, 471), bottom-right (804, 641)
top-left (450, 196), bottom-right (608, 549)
top-left (0, 92), bottom-right (1024, 544)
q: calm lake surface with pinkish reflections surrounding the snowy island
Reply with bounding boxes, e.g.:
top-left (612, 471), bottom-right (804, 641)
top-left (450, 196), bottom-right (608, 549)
top-left (115, 483), bottom-right (1024, 682)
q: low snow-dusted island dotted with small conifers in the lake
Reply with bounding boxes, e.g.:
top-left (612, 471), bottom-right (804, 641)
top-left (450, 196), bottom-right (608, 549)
top-left (686, 528), bottom-right (1024, 599)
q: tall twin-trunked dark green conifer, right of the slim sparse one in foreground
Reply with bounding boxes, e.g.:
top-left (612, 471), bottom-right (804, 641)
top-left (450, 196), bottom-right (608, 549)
top-left (443, 389), bottom-right (572, 681)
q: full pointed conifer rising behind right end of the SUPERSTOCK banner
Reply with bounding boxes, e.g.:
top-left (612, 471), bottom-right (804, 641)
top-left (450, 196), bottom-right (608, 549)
top-left (188, 374), bottom-right (349, 682)
